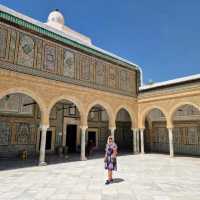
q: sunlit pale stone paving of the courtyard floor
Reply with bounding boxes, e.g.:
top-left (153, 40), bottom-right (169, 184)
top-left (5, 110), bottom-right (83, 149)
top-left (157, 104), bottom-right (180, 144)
top-left (0, 154), bottom-right (200, 200)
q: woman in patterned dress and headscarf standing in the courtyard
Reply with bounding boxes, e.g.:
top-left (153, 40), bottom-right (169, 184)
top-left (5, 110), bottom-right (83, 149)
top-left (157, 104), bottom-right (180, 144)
top-left (104, 136), bottom-right (117, 185)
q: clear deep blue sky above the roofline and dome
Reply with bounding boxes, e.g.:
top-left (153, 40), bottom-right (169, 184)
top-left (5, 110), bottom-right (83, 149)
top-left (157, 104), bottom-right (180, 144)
top-left (0, 0), bottom-right (200, 82)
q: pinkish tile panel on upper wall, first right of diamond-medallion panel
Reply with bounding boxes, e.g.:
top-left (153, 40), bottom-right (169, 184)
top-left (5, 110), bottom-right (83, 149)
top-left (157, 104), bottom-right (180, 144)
top-left (44, 45), bottom-right (56, 72)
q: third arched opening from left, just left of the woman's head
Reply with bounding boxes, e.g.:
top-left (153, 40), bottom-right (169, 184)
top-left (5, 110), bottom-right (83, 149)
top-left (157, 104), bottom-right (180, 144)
top-left (86, 104), bottom-right (110, 157)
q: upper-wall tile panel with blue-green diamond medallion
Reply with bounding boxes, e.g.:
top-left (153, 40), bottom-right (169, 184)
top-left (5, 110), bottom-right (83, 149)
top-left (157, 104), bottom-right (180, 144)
top-left (17, 34), bottom-right (35, 67)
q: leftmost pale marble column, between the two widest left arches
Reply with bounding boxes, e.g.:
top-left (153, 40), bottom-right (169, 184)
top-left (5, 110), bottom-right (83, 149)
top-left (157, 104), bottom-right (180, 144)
top-left (39, 125), bottom-right (49, 166)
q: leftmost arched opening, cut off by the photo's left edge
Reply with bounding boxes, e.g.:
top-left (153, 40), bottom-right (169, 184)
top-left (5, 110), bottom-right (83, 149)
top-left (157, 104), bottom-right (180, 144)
top-left (0, 93), bottom-right (41, 159)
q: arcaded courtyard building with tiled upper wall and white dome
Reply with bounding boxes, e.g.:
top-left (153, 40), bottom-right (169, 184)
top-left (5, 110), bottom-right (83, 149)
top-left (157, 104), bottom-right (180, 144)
top-left (0, 6), bottom-right (200, 164)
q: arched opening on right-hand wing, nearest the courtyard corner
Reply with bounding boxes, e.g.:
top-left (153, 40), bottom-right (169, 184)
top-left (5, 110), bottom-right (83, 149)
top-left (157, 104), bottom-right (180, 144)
top-left (144, 108), bottom-right (169, 153)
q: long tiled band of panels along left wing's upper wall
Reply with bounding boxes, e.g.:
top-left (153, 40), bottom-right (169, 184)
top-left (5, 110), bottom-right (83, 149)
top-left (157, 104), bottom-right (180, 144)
top-left (0, 22), bottom-right (137, 96)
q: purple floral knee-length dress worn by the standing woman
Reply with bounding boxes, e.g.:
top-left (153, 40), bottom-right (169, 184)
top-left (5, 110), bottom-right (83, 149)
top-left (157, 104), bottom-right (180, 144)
top-left (105, 143), bottom-right (117, 171)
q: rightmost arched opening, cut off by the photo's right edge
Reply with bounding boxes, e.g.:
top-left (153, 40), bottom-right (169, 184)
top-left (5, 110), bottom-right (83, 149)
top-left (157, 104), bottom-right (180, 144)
top-left (172, 104), bottom-right (200, 156)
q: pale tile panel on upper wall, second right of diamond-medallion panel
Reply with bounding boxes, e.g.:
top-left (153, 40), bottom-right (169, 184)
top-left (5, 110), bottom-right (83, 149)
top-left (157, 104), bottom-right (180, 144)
top-left (64, 50), bottom-right (75, 78)
